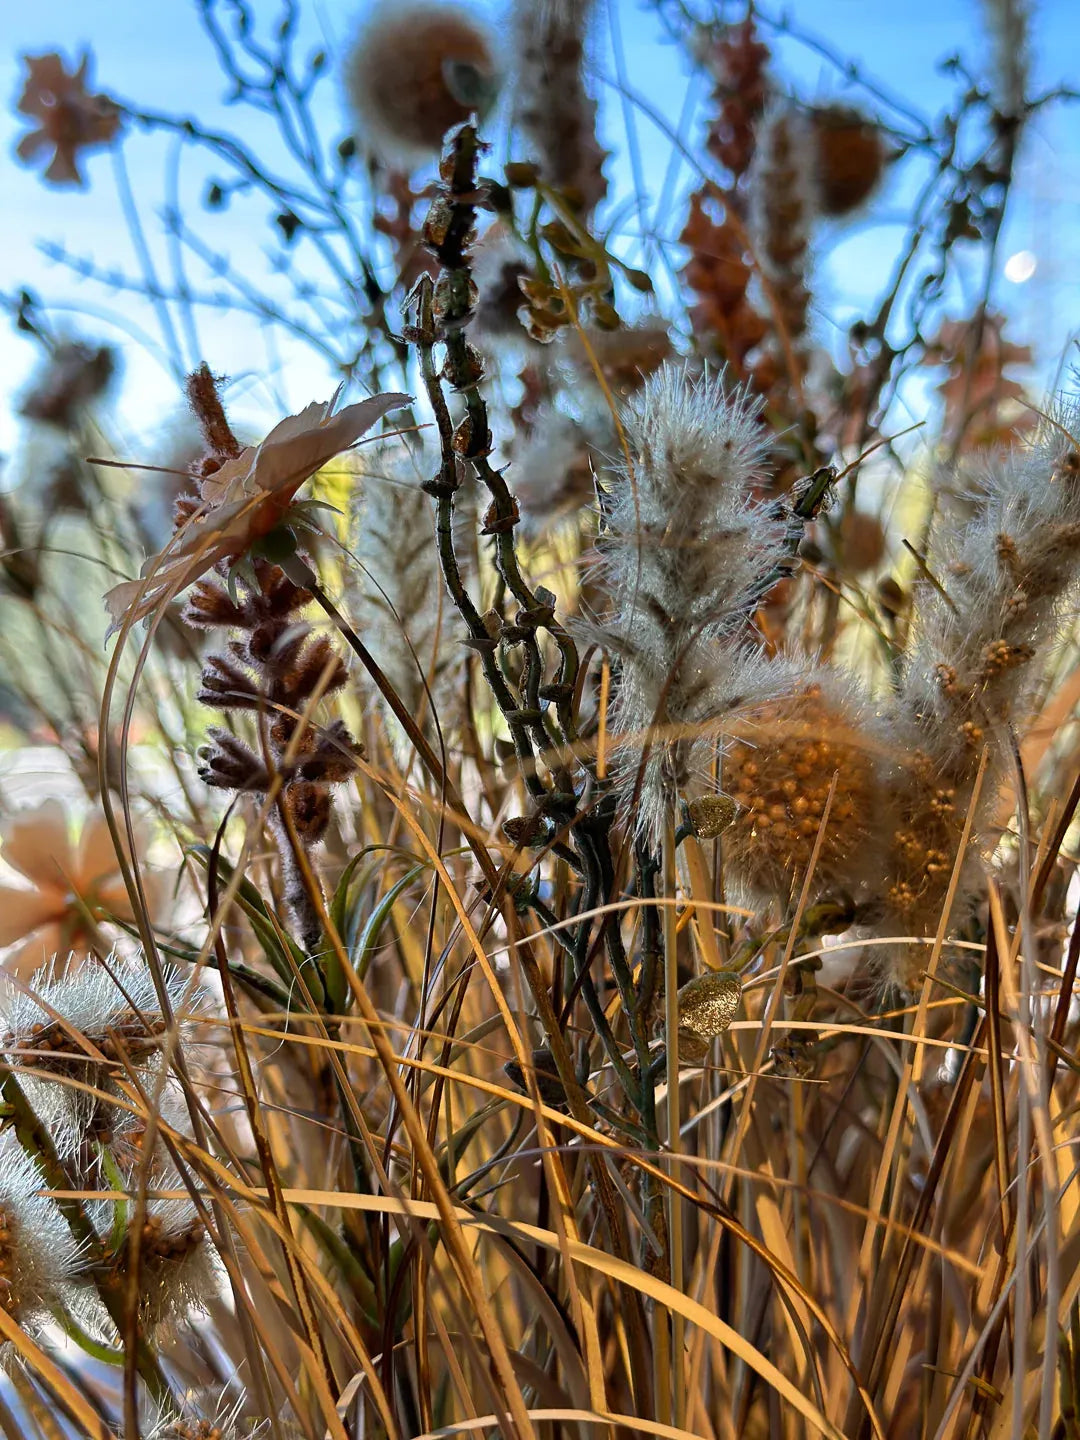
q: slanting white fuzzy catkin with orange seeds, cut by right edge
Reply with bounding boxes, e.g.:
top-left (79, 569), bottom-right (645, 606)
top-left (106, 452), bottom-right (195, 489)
top-left (884, 402), bottom-right (1080, 982)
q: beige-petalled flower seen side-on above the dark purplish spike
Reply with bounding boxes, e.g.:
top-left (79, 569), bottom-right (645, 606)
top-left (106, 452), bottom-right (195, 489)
top-left (105, 395), bottom-right (412, 635)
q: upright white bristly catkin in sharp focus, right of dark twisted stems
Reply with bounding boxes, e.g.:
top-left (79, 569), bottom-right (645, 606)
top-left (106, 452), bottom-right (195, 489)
top-left (593, 366), bottom-right (786, 844)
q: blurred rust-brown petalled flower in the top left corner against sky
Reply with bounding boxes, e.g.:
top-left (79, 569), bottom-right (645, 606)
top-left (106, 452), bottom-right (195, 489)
top-left (16, 52), bottom-right (120, 186)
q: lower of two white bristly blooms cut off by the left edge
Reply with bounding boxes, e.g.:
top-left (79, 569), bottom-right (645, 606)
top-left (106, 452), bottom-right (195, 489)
top-left (0, 1135), bottom-right (79, 1328)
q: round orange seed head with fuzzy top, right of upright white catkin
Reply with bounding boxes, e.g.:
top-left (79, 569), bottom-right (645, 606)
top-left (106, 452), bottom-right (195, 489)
top-left (721, 671), bottom-right (886, 899)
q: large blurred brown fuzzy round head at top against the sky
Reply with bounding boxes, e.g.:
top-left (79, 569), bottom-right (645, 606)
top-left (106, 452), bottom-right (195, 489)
top-left (344, 0), bottom-right (498, 170)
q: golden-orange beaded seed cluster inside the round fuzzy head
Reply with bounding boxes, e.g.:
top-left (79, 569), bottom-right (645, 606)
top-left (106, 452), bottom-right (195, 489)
top-left (724, 687), bottom-right (877, 893)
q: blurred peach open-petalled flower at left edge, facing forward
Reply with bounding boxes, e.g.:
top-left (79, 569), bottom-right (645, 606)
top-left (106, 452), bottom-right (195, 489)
top-left (0, 799), bottom-right (152, 979)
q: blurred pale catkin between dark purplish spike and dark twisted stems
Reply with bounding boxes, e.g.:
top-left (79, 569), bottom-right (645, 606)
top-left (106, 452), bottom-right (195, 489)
top-left (354, 448), bottom-right (465, 763)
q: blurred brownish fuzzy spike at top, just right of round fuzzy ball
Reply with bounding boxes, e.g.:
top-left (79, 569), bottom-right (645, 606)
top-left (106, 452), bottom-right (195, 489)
top-left (513, 0), bottom-right (608, 212)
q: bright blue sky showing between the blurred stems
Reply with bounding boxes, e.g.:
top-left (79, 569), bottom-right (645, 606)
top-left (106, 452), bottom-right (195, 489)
top-left (0, 0), bottom-right (1080, 451)
